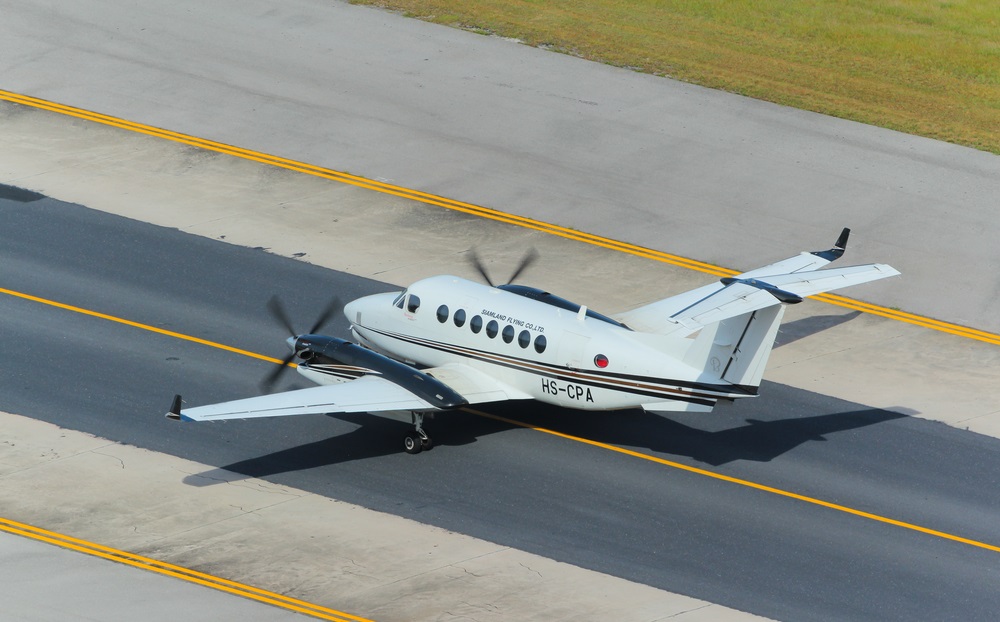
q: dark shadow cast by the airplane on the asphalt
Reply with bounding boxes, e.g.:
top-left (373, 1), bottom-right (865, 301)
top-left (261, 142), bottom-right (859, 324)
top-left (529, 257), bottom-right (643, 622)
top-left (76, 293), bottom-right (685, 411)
top-left (184, 394), bottom-right (907, 486)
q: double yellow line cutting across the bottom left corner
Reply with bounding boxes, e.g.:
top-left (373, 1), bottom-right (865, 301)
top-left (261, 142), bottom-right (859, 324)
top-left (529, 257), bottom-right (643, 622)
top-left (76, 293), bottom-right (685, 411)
top-left (0, 518), bottom-right (371, 622)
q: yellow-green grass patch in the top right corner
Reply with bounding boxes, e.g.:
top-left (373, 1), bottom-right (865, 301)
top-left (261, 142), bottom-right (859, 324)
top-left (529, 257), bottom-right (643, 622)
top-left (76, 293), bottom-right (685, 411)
top-left (355, 0), bottom-right (1000, 153)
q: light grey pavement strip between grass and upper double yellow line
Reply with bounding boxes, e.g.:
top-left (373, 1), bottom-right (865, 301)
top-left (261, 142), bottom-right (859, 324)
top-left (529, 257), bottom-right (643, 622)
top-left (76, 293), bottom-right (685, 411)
top-left (0, 0), bottom-right (1000, 332)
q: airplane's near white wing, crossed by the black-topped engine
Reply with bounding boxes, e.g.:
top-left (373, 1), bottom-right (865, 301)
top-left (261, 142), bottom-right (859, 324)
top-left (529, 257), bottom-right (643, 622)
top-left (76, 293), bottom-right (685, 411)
top-left (167, 364), bottom-right (528, 421)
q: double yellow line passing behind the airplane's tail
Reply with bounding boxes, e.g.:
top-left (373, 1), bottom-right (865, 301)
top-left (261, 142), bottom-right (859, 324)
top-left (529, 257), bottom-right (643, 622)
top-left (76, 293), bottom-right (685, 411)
top-left (0, 90), bottom-right (1000, 345)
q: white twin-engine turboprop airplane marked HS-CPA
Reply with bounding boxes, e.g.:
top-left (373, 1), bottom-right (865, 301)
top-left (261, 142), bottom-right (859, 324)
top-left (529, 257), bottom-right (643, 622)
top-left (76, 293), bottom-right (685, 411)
top-left (167, 229), bottom-right (899, 453)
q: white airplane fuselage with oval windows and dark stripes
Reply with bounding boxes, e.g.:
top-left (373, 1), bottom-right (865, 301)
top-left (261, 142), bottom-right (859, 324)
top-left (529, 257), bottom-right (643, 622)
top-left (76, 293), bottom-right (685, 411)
top-left (336, 276), bottom-right (748, 411)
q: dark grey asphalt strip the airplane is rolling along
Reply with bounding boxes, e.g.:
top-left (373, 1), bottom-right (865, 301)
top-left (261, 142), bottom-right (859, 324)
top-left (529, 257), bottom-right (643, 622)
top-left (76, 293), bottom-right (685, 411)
top-left (0, 183), bottom-right (1000, 619)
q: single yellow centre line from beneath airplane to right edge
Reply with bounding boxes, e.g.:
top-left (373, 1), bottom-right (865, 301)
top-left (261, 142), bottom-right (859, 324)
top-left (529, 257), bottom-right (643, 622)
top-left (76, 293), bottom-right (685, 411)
top-left (462, 408), bottom-right (1000, 553)
